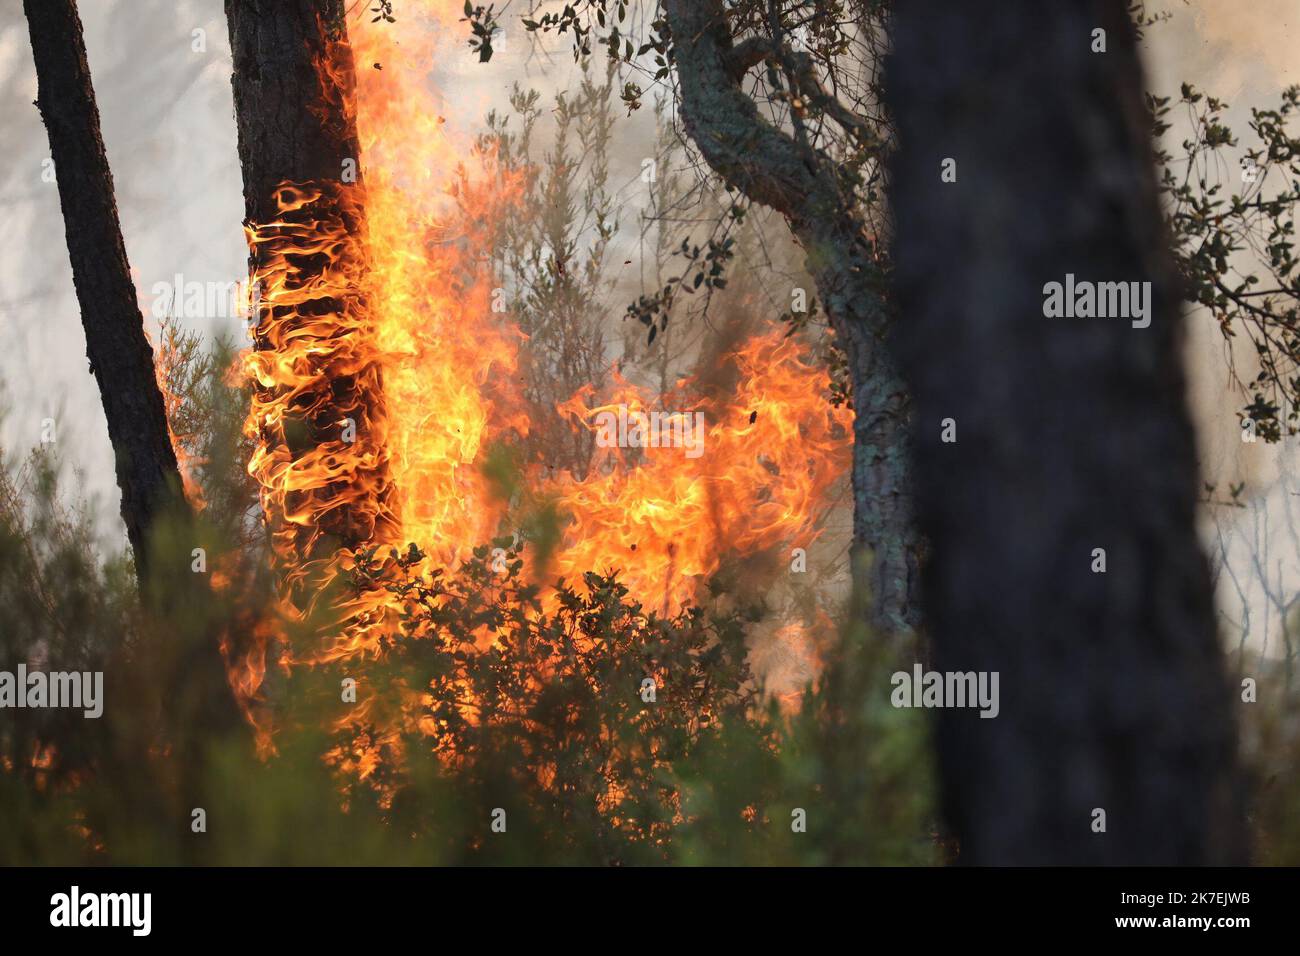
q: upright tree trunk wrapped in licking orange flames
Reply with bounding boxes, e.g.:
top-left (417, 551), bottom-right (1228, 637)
top-left (226, 0), bottom-right (391, 567)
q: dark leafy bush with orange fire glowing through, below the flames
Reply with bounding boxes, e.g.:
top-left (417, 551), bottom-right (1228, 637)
top-left (345, 541), bottom-right (758, 862)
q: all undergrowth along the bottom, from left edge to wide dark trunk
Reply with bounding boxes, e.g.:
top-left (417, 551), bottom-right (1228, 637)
top-left (0, 342), bottom-right (933, 865)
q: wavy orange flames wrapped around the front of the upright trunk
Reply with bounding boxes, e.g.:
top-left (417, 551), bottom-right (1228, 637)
top-left (247, 183), bottom-right (393, 574)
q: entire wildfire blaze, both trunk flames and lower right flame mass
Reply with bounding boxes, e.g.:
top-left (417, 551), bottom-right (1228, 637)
top-left (238, 0), bottom-right (852, 738)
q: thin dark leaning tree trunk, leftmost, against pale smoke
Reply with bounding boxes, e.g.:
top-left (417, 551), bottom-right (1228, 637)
top-left (23, 0), bottom-right (187, 578)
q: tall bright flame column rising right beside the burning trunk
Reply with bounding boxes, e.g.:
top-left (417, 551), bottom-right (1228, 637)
top-left (355, 1), bottom-right (528, 564)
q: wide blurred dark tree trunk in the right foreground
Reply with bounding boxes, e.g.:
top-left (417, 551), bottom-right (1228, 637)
top-left (885, 0), bottom-right (1244, 864)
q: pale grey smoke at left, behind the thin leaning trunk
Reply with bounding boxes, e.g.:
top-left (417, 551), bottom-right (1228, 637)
top-left (0, 0), bottom-right (246, 545)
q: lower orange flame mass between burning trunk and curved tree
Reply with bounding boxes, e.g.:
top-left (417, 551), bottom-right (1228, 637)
top-left (556, 330), bottom-right (853, 614)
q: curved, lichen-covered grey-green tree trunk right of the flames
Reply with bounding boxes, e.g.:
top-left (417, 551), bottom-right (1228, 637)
top-left (663, 0), bottom-right (919, 635)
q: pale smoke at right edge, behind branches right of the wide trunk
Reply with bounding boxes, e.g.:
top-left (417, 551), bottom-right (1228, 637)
top-left (1147, 0), bottom-right (1300, 658)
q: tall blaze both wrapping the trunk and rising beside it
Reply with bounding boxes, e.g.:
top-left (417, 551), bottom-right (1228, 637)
top-left (246, 4), bottom-right (527, 661)
